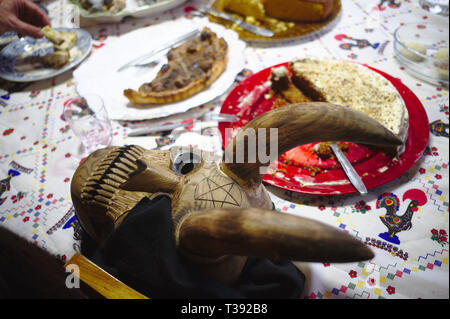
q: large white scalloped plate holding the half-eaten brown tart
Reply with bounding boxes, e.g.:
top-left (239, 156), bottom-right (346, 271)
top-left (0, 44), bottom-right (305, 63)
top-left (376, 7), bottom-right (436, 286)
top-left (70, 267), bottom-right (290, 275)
top-left (73, 19), bottom-right (245, 120)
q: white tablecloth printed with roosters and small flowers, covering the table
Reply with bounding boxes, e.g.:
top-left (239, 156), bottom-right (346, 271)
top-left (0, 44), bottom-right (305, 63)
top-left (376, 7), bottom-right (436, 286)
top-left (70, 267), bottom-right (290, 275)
top-left (0, 0), bottom-right (449, 299)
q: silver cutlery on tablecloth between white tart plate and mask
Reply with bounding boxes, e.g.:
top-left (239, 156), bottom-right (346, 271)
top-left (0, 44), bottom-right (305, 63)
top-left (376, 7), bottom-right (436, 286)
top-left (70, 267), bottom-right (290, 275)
top-left (128, 113), bottom-right (237, 136)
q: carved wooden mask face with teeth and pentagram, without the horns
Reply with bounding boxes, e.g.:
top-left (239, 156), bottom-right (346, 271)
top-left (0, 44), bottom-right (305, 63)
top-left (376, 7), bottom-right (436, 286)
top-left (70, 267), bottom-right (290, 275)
top-left (72, 145), bottom-right (272, 241)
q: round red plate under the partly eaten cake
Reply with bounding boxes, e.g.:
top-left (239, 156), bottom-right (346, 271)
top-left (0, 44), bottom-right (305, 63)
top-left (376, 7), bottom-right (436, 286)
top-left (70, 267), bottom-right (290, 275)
top-left (219, 63), bottom-right (429, 195)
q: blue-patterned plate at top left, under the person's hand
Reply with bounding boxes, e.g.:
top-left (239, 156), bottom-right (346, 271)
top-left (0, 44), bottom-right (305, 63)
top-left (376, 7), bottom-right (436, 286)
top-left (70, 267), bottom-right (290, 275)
top-left (0, 28), bottom-right (92, 82)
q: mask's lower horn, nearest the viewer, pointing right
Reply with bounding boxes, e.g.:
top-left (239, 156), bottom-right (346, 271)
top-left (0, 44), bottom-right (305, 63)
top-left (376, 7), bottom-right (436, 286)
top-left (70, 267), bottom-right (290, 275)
top-left (176, 208), bottom-right (374, 262)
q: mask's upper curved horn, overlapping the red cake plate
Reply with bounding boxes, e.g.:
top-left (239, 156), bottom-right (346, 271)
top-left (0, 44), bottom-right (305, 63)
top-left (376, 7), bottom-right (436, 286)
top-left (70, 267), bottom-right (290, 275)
top-left (221, 102), bottom-right (402, 191)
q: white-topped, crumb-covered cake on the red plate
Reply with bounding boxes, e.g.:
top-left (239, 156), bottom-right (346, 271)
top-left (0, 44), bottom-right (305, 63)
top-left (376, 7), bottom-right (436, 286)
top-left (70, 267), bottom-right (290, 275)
top-left (290, 59), bottom-right (409, 153)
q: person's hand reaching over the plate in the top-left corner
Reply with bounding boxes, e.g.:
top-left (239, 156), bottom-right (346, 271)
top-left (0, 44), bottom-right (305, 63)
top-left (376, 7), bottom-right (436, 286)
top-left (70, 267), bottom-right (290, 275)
top-left (0, 0), bottom-right (50, 38)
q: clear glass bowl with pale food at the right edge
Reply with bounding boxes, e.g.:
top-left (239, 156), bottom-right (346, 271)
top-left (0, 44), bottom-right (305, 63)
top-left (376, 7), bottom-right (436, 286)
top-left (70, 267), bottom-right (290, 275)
top-left (394, 23), bottom-right (449, 86)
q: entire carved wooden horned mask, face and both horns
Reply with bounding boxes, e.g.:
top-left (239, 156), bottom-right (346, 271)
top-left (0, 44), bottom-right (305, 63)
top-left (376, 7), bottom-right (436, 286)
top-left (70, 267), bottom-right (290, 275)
top-left (72, 102), bottom-right (400, 284)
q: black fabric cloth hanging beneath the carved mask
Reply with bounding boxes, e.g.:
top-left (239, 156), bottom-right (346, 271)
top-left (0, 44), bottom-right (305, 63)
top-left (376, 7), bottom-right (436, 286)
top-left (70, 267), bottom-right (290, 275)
top-left (92, 196), bottom-right (305, 299)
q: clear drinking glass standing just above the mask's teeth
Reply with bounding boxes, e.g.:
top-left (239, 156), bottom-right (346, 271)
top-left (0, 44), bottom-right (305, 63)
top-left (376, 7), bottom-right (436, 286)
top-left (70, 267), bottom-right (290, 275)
top-left (63, 94), bottom-right (112, 154)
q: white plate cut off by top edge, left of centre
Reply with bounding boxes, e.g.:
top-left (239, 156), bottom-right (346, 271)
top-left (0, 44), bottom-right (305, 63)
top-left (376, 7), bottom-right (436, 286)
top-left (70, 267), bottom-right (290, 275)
top-left (70, 0), bottom-right (186, 25)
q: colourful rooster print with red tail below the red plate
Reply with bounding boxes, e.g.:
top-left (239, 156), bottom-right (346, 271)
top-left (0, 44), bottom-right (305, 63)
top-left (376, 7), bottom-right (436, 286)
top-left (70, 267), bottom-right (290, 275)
top-left (377, 189), bottom-right (427, 245)
